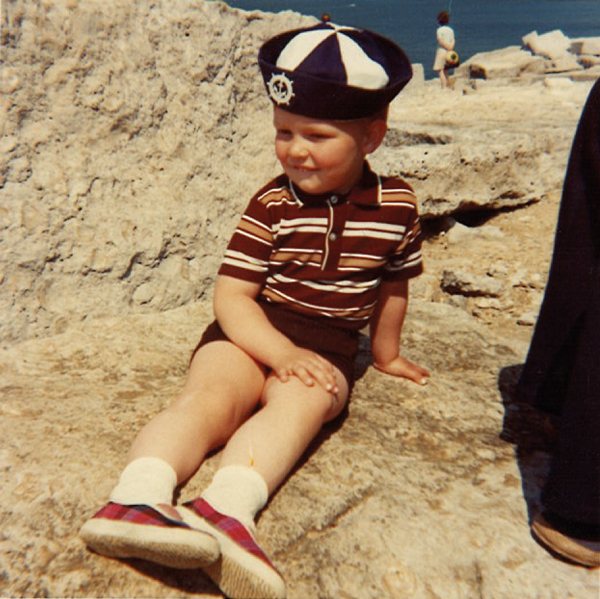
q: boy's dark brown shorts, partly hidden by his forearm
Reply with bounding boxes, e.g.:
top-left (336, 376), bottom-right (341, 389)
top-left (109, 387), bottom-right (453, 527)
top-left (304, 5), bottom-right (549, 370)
top-left (192, 302), bottom-right (359, 391)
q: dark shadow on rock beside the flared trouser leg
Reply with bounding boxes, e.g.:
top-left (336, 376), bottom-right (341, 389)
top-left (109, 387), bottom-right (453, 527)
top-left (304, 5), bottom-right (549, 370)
top-left (498, 364), bottom-right (556, 522)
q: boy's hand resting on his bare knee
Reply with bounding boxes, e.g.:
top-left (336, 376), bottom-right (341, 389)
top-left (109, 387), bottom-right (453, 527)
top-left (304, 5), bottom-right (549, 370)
top-left (273, 347), bottom-right (339, 393)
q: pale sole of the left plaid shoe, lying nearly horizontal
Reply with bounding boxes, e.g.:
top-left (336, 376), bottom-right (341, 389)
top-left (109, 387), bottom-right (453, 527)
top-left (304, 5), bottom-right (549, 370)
top-left (79, 518), bottom-right (220, 569)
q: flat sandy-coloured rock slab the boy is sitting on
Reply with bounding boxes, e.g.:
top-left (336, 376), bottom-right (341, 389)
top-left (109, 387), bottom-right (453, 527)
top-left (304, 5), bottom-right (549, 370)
top-left (0, 301), bottom-right (598, 599)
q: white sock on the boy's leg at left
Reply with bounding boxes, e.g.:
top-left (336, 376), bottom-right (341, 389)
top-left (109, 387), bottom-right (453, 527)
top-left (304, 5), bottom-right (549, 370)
top-left (110, 457), bottom-right (177, 505)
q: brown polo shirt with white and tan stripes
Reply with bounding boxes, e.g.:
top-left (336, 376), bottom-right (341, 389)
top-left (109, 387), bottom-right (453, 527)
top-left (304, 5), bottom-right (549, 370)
top-left (219, 163), bottom-right (423, 329)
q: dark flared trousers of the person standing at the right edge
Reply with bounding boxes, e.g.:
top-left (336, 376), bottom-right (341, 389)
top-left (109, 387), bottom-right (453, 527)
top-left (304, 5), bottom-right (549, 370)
top-left (516, 80), bottom-right (600, 528)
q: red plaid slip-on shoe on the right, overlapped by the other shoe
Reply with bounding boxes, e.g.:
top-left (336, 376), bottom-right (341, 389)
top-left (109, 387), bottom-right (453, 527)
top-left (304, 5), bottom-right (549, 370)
top-left (178, 498), bottom-right (285, 599)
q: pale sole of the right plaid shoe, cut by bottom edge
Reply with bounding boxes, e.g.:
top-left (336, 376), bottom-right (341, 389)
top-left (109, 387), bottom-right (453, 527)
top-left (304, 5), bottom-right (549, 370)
top-left (177, 506), bottom-right (286, 599)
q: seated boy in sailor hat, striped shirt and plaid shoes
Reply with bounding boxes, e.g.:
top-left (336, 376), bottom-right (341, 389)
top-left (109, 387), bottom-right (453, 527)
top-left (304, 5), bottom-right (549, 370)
top-left (81, 23), bottom-right (429, 597)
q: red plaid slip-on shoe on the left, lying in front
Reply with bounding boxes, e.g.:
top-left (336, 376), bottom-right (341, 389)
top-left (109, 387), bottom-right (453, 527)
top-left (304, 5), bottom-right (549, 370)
top-left (79, 502), bottom-right (220, 568)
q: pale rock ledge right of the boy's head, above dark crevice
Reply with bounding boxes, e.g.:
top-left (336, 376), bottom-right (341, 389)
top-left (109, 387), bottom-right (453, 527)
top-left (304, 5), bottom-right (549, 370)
top-left (371, 76), bottom-right (592, 219)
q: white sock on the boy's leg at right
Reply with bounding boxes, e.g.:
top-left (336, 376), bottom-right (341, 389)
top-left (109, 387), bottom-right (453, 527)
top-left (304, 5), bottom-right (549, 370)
top-left (202, 466), bottom-right (269, 532)
